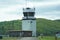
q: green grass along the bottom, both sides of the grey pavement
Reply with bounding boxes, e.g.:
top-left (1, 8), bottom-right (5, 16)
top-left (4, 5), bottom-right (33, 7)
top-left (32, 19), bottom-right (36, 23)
top-left (2, 36), bottom-right (60, 40)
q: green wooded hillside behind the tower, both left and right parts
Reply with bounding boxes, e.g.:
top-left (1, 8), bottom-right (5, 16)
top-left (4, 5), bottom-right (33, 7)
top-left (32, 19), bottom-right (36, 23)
top-left (0, 18), bottom-right (60, 35)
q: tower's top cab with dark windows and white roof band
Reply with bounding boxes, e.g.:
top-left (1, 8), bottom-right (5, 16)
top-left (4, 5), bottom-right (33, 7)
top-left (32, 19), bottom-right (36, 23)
top-left (23, 8), bottom-right (35, 19)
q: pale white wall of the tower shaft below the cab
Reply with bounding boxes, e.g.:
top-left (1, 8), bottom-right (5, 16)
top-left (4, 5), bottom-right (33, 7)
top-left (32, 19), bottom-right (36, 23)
top-left (22, 20), bottom-right (36, 36)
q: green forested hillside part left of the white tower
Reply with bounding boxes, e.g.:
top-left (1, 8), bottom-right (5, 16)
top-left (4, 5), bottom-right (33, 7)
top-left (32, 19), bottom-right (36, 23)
top-left (0, 20), bottom-right (22, 34)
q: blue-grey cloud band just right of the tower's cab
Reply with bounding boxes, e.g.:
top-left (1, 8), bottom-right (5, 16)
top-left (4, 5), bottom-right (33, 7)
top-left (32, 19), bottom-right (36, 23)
top-left (36, 4), bottom-right (60, 14)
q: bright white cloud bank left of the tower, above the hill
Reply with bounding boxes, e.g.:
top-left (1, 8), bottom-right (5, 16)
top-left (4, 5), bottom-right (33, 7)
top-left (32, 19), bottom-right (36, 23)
top-left (0, 5), bottom-right (22, 21)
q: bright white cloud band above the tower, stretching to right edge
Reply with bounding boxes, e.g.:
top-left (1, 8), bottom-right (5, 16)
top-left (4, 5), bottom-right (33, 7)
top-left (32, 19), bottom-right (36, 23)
top-left (27, 1), bottom-right (60, 7)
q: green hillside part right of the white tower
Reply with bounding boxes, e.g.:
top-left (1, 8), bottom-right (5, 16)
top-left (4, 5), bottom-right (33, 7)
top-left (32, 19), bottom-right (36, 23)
top-left (37, 18), bottom-right (60, 35)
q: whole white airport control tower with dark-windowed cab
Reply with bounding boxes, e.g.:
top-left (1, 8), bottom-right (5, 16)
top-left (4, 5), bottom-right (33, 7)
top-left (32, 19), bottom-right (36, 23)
top-left (22, 8), bottom-right (36, 37)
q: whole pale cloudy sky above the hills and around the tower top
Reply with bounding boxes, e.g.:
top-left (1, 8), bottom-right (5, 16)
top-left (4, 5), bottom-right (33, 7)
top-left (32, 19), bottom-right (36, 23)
top-left (0, 0), bottom-right (60, 21)
